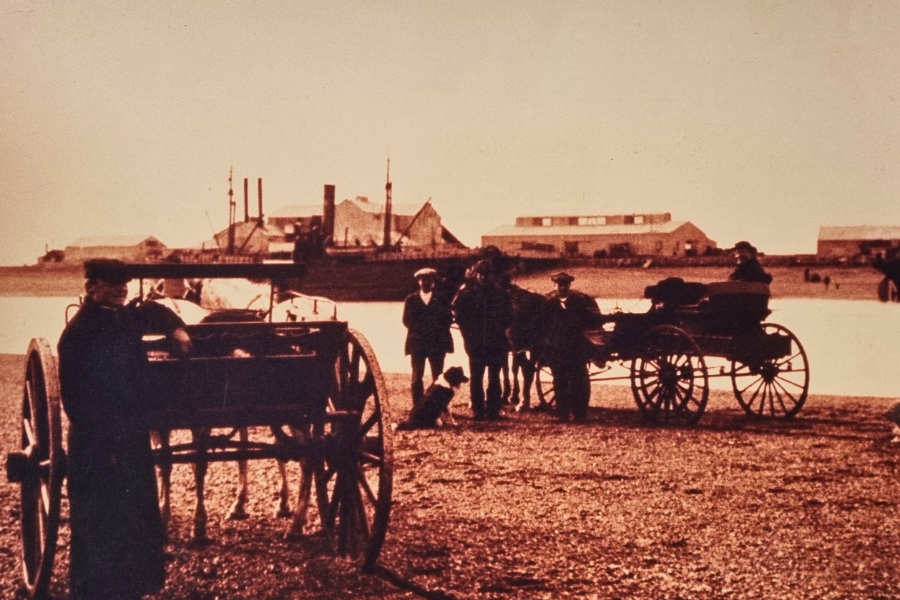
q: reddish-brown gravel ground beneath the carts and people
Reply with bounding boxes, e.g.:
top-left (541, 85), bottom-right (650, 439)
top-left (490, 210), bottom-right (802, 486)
top-left (0, 355), bottom-right (900, 600)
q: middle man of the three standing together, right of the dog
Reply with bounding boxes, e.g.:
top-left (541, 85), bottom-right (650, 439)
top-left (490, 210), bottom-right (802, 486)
top-left (452, 260), bottom-right (512, 421)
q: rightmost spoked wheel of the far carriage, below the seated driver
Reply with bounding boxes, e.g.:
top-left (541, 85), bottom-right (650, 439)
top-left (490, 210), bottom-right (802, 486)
top-left (731, 323), bottom-right (809, 419)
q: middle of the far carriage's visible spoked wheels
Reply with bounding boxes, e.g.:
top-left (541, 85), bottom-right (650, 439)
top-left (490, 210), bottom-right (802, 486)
top-left (631, 325), bottom-right (709, 425)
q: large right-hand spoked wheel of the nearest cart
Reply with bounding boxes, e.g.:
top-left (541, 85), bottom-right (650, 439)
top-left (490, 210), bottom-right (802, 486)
top-left (314, 330), bottom-right (394, 568)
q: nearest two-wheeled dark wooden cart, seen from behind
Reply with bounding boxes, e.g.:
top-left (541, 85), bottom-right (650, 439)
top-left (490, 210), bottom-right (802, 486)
top-left (7, 264), bottom-right (393, 599)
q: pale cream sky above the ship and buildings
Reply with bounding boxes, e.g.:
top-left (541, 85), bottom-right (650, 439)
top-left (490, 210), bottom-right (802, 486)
top-left (0, 0), bottom-right (900, 264)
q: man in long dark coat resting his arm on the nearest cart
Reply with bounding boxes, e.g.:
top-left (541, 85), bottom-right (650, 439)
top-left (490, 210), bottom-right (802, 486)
top-left (59, 259), bottom-right (190, 600)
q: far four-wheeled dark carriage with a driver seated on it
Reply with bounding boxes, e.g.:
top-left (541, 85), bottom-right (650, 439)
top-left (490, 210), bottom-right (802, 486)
top-left (537, 278), bottom-right (809, 425)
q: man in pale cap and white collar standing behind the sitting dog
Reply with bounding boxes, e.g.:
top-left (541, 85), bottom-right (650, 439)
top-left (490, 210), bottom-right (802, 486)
top-left (403, 268), bottom-right (453, 407)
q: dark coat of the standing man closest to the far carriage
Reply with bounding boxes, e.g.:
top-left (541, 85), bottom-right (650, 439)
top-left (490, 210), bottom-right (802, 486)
top-left (543, 290), bottom-right (603, 363)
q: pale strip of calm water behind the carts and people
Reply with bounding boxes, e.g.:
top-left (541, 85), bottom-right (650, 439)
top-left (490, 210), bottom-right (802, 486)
top-left (0, 297), bottom-right (900, 397)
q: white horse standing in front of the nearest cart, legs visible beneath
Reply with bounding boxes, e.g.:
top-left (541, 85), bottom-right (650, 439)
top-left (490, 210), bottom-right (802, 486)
top-left (152, 279), bottom-right (337, 542)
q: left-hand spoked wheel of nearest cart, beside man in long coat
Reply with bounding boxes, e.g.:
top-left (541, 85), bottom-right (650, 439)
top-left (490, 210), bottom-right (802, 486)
top-left (6, 339), bottom-right (65, 600)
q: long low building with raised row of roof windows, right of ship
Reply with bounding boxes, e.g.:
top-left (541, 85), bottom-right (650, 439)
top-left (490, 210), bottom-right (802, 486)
top-left (481, 213), bottom-right (716, 258)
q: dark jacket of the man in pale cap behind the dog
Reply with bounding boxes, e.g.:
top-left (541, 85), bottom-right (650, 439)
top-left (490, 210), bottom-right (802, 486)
top-left (403, 291), bottom-right (453, 356)
